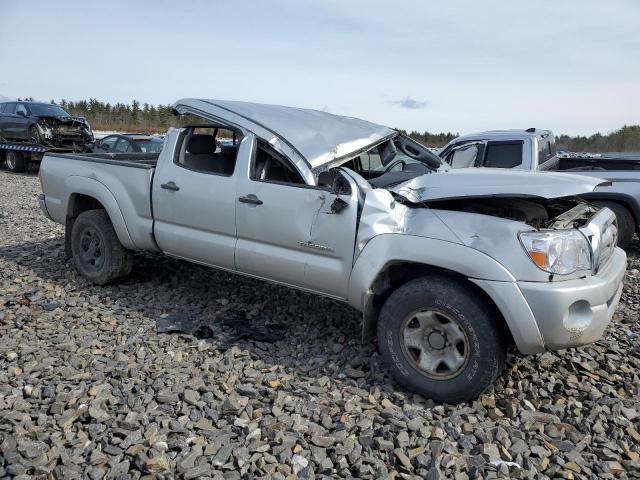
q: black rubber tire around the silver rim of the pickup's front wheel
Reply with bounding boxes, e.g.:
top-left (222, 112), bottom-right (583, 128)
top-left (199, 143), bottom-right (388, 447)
top-left (378, 276), bottom-right (507, 404)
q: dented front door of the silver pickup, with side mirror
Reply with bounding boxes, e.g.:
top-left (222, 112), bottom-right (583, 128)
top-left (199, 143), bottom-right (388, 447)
top-left (236, 139), bottom-right (358, 298)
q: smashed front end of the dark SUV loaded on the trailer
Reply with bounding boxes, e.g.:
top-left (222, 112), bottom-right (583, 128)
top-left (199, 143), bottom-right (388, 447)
top-left (34, 117), bottom-right (94, 152)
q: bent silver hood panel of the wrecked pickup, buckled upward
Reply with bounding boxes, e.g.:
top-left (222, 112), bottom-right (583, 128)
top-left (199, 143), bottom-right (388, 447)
top-left (388, 168), bottom-right (609, 203)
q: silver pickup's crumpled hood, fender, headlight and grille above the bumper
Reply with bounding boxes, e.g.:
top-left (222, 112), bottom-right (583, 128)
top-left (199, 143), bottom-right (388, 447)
top-left (356, 170), bottom-right (617, 282)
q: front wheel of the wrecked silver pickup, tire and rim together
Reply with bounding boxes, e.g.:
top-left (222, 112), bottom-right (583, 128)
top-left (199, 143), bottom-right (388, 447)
top-left (378, 276), bottom-right (507, 404)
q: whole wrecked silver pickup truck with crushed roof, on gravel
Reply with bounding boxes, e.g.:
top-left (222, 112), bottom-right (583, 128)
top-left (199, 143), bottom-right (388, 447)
top-left (40, 99), bottom-right (626, 403)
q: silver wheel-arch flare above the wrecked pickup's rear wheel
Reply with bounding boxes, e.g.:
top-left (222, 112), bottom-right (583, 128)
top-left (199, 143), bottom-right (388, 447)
top-left (64, 175), bottom-right (137, 250)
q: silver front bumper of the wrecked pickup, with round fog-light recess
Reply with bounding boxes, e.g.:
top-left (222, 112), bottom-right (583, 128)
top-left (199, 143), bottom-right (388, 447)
top-left (518, 248), bottom-right (627, 350)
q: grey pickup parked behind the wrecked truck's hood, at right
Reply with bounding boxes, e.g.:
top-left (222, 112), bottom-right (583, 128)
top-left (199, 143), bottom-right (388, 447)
top-left (439, 128), bottom-right (640, 248)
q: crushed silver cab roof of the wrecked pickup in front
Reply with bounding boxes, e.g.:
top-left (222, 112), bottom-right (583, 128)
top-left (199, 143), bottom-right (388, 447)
top-left (173, 98), bottom-right (397, 168)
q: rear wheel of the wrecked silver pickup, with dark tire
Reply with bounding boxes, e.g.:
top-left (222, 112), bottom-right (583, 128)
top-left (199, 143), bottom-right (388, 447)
top-left (71, 210), bottom-right (133, 285)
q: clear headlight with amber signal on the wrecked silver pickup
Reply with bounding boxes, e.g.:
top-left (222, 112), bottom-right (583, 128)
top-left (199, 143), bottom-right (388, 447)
top-left (520, 230), bottom-right (592, 274)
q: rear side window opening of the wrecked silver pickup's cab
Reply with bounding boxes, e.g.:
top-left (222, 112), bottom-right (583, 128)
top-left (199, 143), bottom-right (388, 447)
top-left (176, 126), bottom-right (242, 177)
